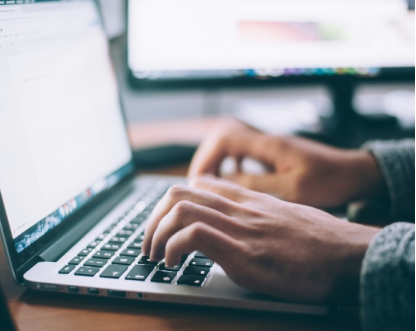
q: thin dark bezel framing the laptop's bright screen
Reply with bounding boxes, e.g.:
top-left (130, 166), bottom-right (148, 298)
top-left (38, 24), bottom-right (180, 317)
top-left (0, 0), bottom-right (135, 284)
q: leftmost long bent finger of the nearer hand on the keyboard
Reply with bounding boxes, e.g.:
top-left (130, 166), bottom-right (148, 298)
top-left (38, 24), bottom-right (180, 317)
top-left (143, 186), bottom-right (237, 255)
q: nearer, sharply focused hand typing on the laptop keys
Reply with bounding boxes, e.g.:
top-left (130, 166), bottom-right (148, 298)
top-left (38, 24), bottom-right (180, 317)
top-left (143, 177), bottom-right (378, 303)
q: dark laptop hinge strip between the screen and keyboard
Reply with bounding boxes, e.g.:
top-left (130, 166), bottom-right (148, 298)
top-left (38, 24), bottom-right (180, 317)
top-left (38, 182), bottom-right (134, 262)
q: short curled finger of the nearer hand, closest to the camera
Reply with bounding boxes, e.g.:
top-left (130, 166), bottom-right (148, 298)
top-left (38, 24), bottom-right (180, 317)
top-left (162, 223), bottom-right (241, 267)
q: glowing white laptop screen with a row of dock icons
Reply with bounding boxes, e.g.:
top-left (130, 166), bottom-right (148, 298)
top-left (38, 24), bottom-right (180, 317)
top-left (0, 0), bottom-right (133, 253)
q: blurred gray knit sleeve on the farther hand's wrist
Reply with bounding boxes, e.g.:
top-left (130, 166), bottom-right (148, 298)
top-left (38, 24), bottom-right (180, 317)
top-left (364, 140), bottom-right (415, 220)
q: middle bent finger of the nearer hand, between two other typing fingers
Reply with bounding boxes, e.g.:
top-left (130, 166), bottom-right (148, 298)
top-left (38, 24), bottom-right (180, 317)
top-left (150, 201), bottom-right (244, 261)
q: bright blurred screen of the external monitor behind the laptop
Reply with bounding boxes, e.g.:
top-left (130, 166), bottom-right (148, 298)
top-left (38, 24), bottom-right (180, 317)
top-left (129, 0), bottom-right (415, 80)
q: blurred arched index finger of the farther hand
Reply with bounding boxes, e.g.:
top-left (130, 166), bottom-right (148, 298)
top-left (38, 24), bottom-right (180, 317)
top-left (189, 130), bottom-right (273, 178)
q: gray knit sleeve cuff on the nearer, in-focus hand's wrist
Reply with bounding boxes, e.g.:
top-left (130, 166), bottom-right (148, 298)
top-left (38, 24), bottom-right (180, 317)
top-left (361, 223), bottom-right (415, 331)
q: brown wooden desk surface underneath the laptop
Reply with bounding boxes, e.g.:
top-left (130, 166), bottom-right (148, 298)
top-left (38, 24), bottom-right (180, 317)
top-left (0, 121), bottom-right (360, 331)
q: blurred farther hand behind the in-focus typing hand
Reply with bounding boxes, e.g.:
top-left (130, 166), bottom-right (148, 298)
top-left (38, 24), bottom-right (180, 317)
top-left (189, 120), bottom-right (387, 208)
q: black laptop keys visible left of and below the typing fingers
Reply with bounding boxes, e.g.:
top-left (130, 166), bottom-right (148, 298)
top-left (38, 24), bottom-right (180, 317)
top-left (59, 182), bottom-right (214, 287)
